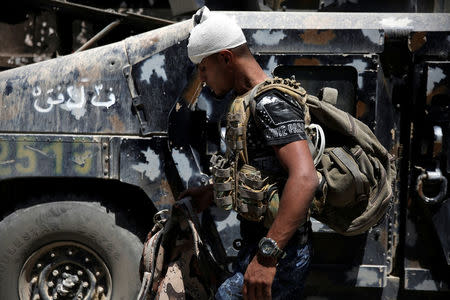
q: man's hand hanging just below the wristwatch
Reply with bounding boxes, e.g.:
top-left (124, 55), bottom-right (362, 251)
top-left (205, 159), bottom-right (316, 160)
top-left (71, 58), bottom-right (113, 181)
top-left (242, 254), bottom-right (277, 300)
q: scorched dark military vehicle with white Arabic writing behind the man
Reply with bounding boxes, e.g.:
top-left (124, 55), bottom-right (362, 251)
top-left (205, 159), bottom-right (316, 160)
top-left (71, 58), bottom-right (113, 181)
top-left (0, 5), bottom-right (450, 299)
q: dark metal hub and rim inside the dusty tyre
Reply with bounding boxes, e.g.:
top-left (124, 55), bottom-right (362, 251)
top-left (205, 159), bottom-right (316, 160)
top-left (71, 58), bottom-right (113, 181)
top-left (19, 242), bottom-right (112, 300)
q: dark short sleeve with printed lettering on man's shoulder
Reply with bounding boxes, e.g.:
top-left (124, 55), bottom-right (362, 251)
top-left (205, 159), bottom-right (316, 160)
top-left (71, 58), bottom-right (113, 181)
top-left (251, 90), bottom-right (306, 145)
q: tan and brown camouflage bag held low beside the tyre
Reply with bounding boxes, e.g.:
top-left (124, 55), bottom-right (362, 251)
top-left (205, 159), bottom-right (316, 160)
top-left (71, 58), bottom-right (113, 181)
top-left (137, 198), bottom-right (230, 300)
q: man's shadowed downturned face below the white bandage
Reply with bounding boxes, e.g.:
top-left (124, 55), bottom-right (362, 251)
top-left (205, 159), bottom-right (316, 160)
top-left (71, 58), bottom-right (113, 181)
top-left (197, 53), bottom-right (233, 98)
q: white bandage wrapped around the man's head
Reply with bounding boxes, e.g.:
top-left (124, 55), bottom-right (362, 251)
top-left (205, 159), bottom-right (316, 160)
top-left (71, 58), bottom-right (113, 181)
top-left (187, 6), bottom-right (247, 64)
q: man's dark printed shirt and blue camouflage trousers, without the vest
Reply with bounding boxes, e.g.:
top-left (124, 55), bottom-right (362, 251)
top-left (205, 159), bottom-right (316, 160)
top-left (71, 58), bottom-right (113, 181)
top-left (216, 90), bottom-right (312, 299)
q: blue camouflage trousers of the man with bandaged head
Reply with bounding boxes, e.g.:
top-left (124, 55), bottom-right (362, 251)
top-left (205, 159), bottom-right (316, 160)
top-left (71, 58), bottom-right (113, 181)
top-left (216, 230), bottom-right (312, 300)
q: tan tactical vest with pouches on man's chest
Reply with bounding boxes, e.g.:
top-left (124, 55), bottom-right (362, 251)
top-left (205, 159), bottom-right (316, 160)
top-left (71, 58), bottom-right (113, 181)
top-left (211, 78), bottom-right (307, 227)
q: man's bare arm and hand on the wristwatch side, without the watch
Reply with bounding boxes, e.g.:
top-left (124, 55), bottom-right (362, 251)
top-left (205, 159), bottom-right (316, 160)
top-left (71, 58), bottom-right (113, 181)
top-left (242, 140), bottom-right (318, 300)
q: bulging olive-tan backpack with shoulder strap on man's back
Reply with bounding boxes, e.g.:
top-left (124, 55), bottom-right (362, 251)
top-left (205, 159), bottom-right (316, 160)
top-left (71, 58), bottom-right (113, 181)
top-left (244, 77), bottom-right (396, 235)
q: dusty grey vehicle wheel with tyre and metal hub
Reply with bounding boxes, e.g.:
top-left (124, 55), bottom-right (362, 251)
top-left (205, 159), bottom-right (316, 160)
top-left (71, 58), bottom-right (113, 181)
top-left (0, 201), bottom-right (142, 300)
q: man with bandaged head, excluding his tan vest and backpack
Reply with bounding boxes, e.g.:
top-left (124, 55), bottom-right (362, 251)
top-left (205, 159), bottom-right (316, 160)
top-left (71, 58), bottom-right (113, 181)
top-left (180, 8), bottom-right (318, 299)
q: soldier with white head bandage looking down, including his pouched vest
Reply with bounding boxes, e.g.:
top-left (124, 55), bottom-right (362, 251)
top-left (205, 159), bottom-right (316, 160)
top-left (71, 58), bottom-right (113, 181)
top-left (180, 7), bottom-right (318, 299)
